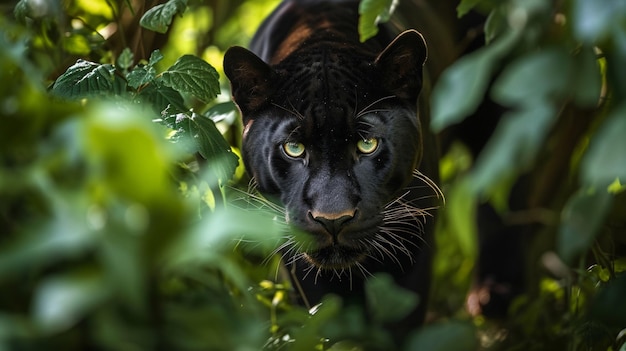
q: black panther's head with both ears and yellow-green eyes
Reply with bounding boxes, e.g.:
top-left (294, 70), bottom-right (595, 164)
top-left (224, 31), bottom-right (426, 269)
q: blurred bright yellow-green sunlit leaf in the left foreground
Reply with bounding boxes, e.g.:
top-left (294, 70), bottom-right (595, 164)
top-left (82, 104), bottom-right (173, 203)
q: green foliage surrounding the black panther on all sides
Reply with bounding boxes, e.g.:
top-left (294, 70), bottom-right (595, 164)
top-left (0, 0), bottom-right (626, 351)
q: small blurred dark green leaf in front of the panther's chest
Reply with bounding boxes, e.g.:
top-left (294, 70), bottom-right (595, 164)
top-left (365, 274), bottom-right (419, 323)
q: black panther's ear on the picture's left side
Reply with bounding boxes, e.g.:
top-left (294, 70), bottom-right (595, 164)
top-left (224, 46), bottom-right (273, 118)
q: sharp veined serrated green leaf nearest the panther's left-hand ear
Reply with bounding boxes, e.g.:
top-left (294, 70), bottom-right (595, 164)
top-left (160, 55), bottom-right (220, 102)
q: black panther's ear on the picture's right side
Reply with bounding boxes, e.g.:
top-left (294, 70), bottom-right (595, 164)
top-left (375, 29), bottom-right (427, 101)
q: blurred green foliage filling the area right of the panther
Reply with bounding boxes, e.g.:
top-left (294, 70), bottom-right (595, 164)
top-left (432, 0), bottom-right (626, 350)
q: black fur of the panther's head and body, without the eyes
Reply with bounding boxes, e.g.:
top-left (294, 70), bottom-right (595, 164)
top-left (224, 1), bottom-right (438, 346)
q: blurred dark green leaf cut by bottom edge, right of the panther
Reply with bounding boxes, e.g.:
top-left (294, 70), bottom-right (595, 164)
top-left (407, 321), bottom-right (478, 351)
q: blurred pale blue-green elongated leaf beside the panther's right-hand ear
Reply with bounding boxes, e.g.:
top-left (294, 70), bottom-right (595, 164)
top-left (431, 31), bottom-right (519, 131)
